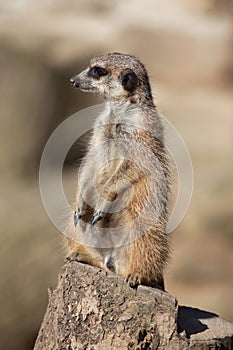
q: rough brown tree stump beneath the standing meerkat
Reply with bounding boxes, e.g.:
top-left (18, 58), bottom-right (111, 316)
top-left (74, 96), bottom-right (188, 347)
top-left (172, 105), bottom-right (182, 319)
top-left (34, 262), bottom-right (233, 350)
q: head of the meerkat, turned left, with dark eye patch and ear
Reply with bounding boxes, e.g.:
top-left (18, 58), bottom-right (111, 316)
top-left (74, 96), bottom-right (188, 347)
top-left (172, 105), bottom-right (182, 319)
top-left (70, 53), bottom-right (152, 103)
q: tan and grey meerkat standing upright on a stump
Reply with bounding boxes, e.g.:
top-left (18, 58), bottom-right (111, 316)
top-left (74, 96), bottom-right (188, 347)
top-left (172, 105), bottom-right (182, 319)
top-left (68, 53), bottom-right (170, 289)
